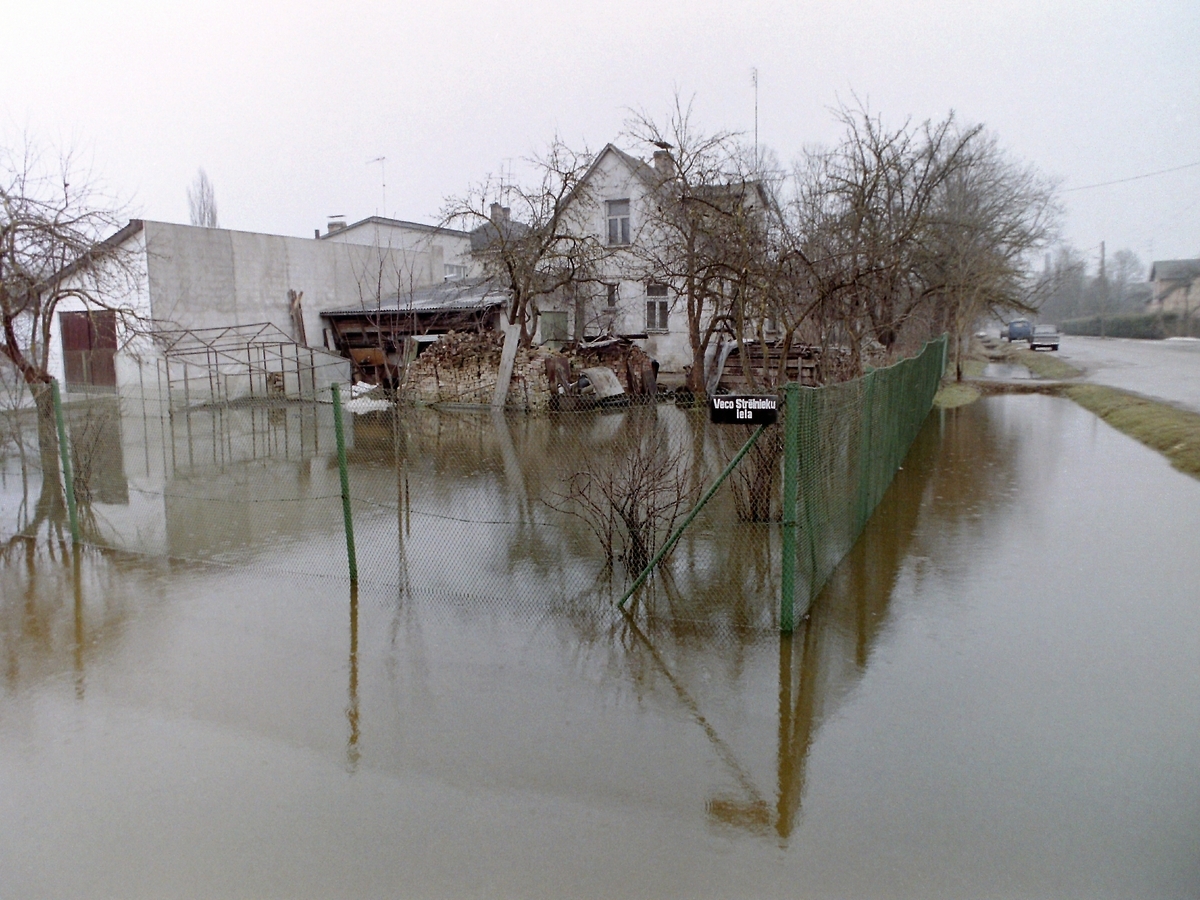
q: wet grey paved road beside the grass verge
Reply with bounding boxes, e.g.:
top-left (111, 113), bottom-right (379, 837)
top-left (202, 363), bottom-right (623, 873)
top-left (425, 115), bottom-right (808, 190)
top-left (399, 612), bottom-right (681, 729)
top-left (1058, 335), bottom-right (1200, 413)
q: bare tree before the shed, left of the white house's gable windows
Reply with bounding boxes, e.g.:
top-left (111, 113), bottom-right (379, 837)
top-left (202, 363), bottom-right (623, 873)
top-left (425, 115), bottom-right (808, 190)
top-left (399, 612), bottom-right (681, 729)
top-left (442, 138), bottom-right (611, 347)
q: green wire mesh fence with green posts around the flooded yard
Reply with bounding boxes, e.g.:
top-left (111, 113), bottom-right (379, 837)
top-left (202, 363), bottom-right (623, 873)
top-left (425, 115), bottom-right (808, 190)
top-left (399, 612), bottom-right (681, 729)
top-left (0, 342), bottom-right (942, 629)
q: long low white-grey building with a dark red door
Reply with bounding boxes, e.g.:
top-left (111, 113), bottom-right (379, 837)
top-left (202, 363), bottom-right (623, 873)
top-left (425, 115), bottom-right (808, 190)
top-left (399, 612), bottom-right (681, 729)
top-left (50, 220), bottom-right (445, 400)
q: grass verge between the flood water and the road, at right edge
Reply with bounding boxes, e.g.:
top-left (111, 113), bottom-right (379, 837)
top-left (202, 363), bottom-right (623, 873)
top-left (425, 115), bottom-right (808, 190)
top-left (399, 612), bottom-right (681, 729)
top-left (1062, 384), bottom-right (1200, 479)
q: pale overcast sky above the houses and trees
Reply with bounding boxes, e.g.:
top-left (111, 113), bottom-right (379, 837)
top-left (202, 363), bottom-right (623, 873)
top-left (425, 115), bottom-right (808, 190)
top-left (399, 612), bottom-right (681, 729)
top-left (0, 0), bottom-right (1200, 271)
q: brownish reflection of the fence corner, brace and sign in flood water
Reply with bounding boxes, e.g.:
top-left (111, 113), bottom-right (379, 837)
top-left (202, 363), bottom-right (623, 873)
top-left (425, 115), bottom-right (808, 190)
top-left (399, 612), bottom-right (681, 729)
top-left (637, 408), bottom-right (1016, 844)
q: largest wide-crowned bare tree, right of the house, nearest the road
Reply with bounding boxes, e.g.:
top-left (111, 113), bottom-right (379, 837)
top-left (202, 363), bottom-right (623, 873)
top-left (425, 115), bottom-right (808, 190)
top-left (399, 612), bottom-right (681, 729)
top-left (780, 104), bottom-right (1058, 376)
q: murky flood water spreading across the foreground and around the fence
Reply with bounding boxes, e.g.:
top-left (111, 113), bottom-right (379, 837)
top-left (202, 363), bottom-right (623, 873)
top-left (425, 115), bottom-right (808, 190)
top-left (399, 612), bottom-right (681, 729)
top-left (0, 396), bottom-right (1200, 900)
